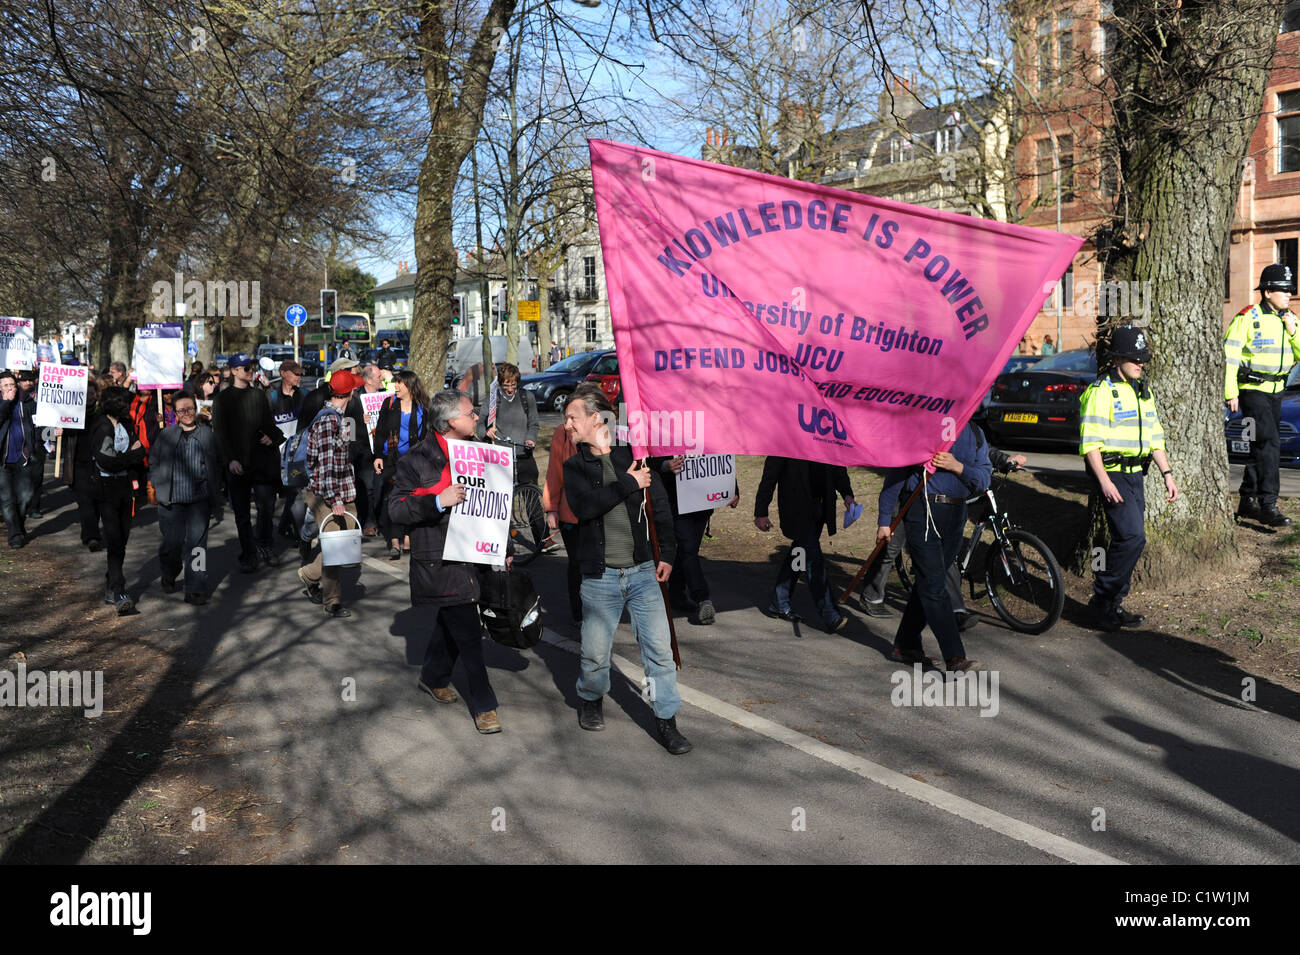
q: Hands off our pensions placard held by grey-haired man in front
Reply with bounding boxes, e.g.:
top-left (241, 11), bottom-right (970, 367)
top-left (442, 438), bottom-right (515, 564)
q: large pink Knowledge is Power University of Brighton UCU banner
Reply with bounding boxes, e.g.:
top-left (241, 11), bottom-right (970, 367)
top-left (590, 139), bottom-right (1083, 466)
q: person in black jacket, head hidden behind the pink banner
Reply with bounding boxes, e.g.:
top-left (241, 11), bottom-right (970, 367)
top-left (754, 457), bottom-right (853, 633)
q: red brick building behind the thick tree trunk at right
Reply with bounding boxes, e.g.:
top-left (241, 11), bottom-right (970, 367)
top-left (1015, 0), bottom-right (1300, 351)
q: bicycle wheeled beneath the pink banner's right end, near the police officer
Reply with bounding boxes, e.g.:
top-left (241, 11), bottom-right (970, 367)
top-left (896, 468), bottom-right (1065, 634)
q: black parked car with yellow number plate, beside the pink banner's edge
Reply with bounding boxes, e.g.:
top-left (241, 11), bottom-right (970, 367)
top-left (984, 348), bottom-right (1097, 448)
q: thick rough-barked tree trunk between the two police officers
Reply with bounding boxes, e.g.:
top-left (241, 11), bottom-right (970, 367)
top-left (1092, 0), bottom-right (1281, 587)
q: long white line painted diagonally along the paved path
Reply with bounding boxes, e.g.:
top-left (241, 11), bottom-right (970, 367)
top-left (542, 629), bottom-right (1127, 865)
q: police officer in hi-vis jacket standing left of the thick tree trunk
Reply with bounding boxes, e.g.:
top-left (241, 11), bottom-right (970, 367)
top-left (1079, 325), bottom-right (1178, 631)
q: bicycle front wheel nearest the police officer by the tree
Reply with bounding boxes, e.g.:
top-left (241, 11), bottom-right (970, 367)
top-left (984, 528), bottom-right (1065, 633)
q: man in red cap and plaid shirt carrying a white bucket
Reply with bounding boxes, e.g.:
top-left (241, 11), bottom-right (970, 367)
top-left (298, 369), bottom-right (361, 617)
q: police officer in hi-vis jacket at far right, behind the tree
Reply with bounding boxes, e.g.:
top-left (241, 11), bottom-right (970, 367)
top-left (1223, 265), bottom-right (1300, 528)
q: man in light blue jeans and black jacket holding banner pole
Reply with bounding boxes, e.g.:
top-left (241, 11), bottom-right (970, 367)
top-left (564, 392), bottom-right (692, 756)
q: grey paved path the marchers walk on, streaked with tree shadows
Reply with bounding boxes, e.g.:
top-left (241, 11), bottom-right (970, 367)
top-left (12, 478), bottom-right (1300, 864)
